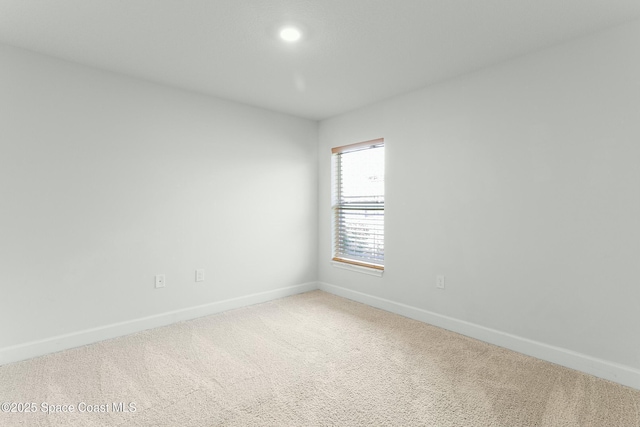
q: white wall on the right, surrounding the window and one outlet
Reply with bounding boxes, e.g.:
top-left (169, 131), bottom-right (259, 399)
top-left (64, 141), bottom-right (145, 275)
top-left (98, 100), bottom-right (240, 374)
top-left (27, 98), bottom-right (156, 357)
top-left (319, 21), bottom-right (640, 378)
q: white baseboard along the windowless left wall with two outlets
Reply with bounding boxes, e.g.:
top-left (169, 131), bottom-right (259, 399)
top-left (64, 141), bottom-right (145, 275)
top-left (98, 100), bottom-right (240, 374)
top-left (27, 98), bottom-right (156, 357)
top-left (0, 282), bottom-right (318, 365)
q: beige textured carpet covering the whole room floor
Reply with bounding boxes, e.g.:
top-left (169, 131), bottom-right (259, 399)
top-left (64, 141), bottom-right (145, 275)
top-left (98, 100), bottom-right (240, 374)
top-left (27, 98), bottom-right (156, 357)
top-left (0, 291), bottom-right (640, 427)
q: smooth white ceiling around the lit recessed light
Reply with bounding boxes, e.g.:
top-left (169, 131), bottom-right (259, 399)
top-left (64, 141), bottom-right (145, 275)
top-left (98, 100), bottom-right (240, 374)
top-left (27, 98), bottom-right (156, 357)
top-left (0, 0), bottom-right (640, 120)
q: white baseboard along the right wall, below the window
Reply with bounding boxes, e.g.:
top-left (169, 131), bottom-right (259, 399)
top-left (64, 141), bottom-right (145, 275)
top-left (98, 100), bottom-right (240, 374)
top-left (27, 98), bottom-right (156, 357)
top-left (318, 282), bottom-right (640, 390)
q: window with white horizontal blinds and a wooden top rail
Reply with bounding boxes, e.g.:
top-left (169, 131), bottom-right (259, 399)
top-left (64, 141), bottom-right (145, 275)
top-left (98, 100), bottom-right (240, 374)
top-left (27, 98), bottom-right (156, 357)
top-left (331, 139), bottom-right (384, 270)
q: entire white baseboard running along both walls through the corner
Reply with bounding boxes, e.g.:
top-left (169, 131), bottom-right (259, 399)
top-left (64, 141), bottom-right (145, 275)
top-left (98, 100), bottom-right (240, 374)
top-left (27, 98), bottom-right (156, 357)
top-left (0, 282), bottom-right (640, 390)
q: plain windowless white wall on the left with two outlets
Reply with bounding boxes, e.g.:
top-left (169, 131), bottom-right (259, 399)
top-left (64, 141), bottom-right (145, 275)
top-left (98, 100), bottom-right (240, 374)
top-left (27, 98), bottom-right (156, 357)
top-left (0, 46), bottom-right (317, 361)
